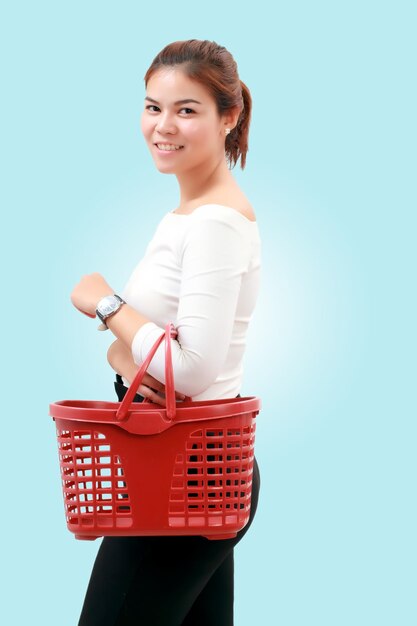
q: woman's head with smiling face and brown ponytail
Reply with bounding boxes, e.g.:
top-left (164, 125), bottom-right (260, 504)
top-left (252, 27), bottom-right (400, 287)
top-left (142, 40), bottom-right (252, 178)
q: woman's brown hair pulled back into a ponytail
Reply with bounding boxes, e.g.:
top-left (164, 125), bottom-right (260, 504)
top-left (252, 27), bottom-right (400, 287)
top-left (144, 39), bottom-right (252, 170)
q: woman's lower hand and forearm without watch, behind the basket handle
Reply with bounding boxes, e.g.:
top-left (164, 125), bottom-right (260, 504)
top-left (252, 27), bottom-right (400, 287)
top-left (107, 339), bottom-right (185, 406)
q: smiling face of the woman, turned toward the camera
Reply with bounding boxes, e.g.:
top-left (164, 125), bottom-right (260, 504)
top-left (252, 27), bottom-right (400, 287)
top-left (141, 67), bottom-right (226, 174)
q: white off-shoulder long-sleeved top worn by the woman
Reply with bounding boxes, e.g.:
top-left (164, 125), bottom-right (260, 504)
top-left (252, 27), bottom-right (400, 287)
top-left (120, 204), bottom-right (261, 400)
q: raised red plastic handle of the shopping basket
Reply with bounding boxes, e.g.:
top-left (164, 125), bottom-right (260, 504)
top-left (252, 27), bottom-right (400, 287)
top-left (116, 322), bottom-right (178, 421)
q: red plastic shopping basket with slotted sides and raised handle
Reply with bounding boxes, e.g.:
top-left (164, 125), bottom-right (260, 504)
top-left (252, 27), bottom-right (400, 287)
top-left (49, 323), bottom-right (261, 539)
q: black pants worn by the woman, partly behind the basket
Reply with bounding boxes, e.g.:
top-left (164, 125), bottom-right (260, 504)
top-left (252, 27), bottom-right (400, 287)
top-left (78, 375), bottom-right (260, 626)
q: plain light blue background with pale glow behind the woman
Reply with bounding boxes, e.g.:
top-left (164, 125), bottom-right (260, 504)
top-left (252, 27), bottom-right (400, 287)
top-left (0, 0), bottom-right (417, 626)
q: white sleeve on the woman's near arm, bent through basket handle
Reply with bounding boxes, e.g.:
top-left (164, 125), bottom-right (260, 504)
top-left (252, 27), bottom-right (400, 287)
top-left (131, 209), bottom-right (258, 397)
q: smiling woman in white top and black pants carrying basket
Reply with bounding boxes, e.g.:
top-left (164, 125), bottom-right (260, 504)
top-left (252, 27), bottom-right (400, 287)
top-left (73, 39), bottom-right (261, 626)
